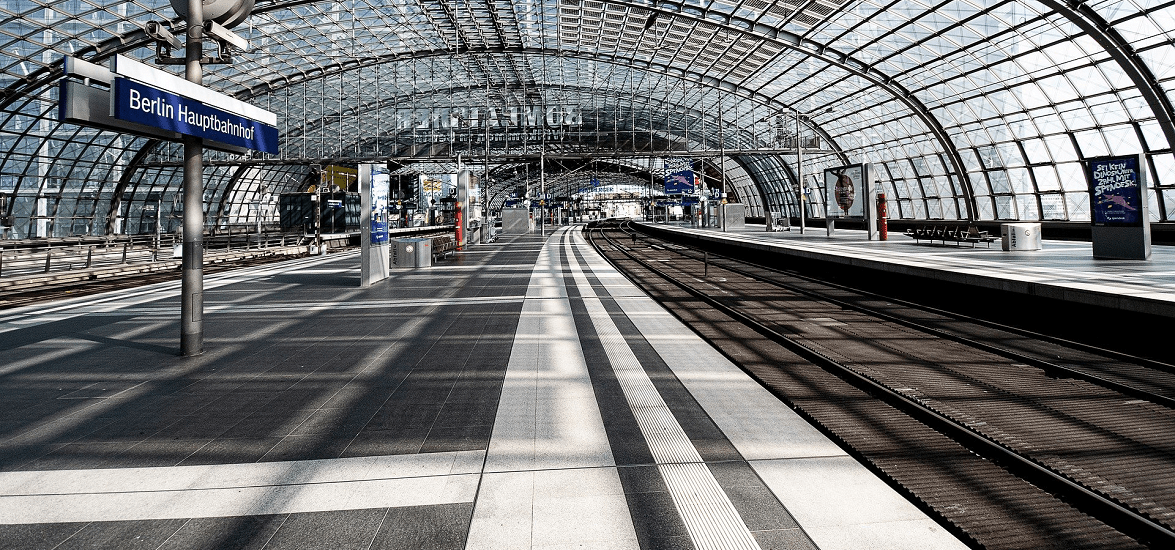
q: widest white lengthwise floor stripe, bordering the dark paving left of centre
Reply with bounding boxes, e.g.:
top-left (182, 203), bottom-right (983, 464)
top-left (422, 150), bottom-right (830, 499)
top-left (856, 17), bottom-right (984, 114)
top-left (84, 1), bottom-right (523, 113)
top-left (465, 227), bottom-right (639, 550)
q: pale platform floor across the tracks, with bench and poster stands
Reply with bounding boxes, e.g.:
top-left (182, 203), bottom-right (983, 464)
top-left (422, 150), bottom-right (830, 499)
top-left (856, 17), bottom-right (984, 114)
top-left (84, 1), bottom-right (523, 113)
top-left (650, 219), bottom-right (1175, 317)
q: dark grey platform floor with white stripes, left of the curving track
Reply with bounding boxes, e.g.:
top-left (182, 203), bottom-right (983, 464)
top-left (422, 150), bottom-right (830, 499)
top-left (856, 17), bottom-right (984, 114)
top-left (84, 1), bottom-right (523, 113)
top-left (0, 228), bottom-right (965, 550)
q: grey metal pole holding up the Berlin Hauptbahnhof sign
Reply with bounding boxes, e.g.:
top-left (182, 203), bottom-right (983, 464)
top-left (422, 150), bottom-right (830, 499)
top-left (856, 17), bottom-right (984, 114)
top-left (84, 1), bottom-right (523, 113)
top-left (180, 0), bottom-right (204, 357)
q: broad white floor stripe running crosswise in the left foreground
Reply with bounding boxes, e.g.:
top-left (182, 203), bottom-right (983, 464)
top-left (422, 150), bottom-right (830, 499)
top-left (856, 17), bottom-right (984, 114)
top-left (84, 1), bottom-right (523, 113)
top-left (0, 451), bottom-right (484, 524)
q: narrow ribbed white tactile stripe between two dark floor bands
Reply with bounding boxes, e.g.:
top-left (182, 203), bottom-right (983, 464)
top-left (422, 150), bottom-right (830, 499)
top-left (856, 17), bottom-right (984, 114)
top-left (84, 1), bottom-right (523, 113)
top-left (564, 232), bottom-right (759, 550)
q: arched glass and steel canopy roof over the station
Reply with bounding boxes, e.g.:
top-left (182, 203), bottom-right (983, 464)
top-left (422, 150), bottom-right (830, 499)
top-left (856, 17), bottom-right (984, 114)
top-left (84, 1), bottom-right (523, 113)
top-left (0, 0), bottom-right (1175, 237)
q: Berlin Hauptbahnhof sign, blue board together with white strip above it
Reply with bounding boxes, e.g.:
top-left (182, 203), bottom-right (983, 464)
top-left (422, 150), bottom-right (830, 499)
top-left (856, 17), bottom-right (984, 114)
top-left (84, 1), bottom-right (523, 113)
top-left (110, 55), bottom-right (278, 154)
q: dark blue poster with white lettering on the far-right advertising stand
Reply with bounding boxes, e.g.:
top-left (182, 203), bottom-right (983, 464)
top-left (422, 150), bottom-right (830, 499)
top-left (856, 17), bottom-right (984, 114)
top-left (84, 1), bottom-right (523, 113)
top-left (1086, 155), bottom-right (1144, 226)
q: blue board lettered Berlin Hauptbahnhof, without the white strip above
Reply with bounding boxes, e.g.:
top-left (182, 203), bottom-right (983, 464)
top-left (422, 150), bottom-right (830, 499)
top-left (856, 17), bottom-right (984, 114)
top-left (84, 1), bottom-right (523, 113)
top-left (114, 78), bottom-right (277, 155)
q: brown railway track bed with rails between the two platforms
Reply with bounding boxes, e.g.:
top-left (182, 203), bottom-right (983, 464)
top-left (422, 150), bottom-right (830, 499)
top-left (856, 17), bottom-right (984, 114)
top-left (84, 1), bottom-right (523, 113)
top-left (589, 219), bottom-right (1175, 549)
